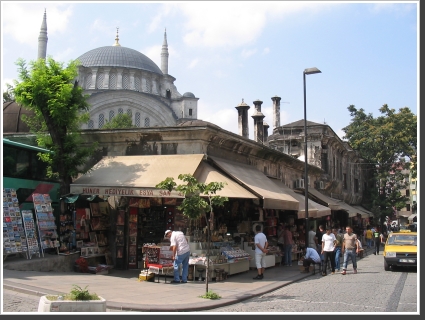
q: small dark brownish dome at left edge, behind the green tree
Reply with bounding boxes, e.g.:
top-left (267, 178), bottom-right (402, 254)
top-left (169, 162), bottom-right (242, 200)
top-left (3, 101), bottom-right (34, 133)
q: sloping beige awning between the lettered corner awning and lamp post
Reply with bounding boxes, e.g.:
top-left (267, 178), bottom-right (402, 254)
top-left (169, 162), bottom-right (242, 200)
top-left (209, 156), bottom-right (299, 211)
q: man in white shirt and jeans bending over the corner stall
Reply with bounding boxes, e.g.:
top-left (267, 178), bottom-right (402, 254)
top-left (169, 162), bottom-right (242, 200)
top-left (164, 230), bottom-right (190, 284)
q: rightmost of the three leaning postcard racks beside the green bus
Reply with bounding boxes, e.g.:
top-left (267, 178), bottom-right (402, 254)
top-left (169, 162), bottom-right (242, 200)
top-left (32, 193), bottom-right (60, 257)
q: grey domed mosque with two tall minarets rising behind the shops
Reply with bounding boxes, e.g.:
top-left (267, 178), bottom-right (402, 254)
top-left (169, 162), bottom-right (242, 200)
top-left (3, 12), bottom-right (199, 132)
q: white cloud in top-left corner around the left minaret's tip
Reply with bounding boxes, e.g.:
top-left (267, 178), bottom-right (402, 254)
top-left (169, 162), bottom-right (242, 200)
top-left (2, 2), bottom-right (73, 47)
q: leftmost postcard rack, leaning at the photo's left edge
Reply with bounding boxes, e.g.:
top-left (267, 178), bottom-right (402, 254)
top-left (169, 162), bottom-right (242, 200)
top-left (3, 188), bottom-right (28, 259)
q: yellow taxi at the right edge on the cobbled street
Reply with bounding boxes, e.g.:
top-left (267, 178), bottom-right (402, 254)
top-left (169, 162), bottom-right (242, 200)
top-left (384, 230), bottom-right (418, 271)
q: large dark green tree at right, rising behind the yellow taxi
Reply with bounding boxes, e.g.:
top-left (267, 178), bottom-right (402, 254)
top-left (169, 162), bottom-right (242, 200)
top-left (343, 104), bottom-right (417, 228)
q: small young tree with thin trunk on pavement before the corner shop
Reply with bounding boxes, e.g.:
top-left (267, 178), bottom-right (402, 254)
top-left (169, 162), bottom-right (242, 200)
top-left (155, 174), bottom-right (229, 293)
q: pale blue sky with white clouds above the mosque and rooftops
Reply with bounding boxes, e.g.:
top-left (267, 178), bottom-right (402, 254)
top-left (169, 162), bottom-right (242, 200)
top-left (1, 1), bottom-right (419, 139)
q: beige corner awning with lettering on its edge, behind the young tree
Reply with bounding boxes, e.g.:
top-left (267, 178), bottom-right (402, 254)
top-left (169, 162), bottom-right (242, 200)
top-left (71, 154), bottom-right (258, 199)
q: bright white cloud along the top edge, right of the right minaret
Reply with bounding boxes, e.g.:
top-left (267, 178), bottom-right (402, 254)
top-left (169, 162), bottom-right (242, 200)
top-left (159, 1), bottom-right (328, 48)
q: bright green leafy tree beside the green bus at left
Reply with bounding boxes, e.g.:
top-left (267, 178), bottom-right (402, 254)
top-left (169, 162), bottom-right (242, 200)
top-left (14, 57), bottom-right (97, 195)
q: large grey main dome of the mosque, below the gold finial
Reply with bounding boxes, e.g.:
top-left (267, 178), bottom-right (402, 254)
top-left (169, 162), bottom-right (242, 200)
top-left (78, 46), bottom-right (162, 75)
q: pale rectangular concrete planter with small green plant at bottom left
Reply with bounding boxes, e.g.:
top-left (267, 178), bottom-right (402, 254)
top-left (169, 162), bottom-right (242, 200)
top-left (38, 284), bottom-right (106, 312)
